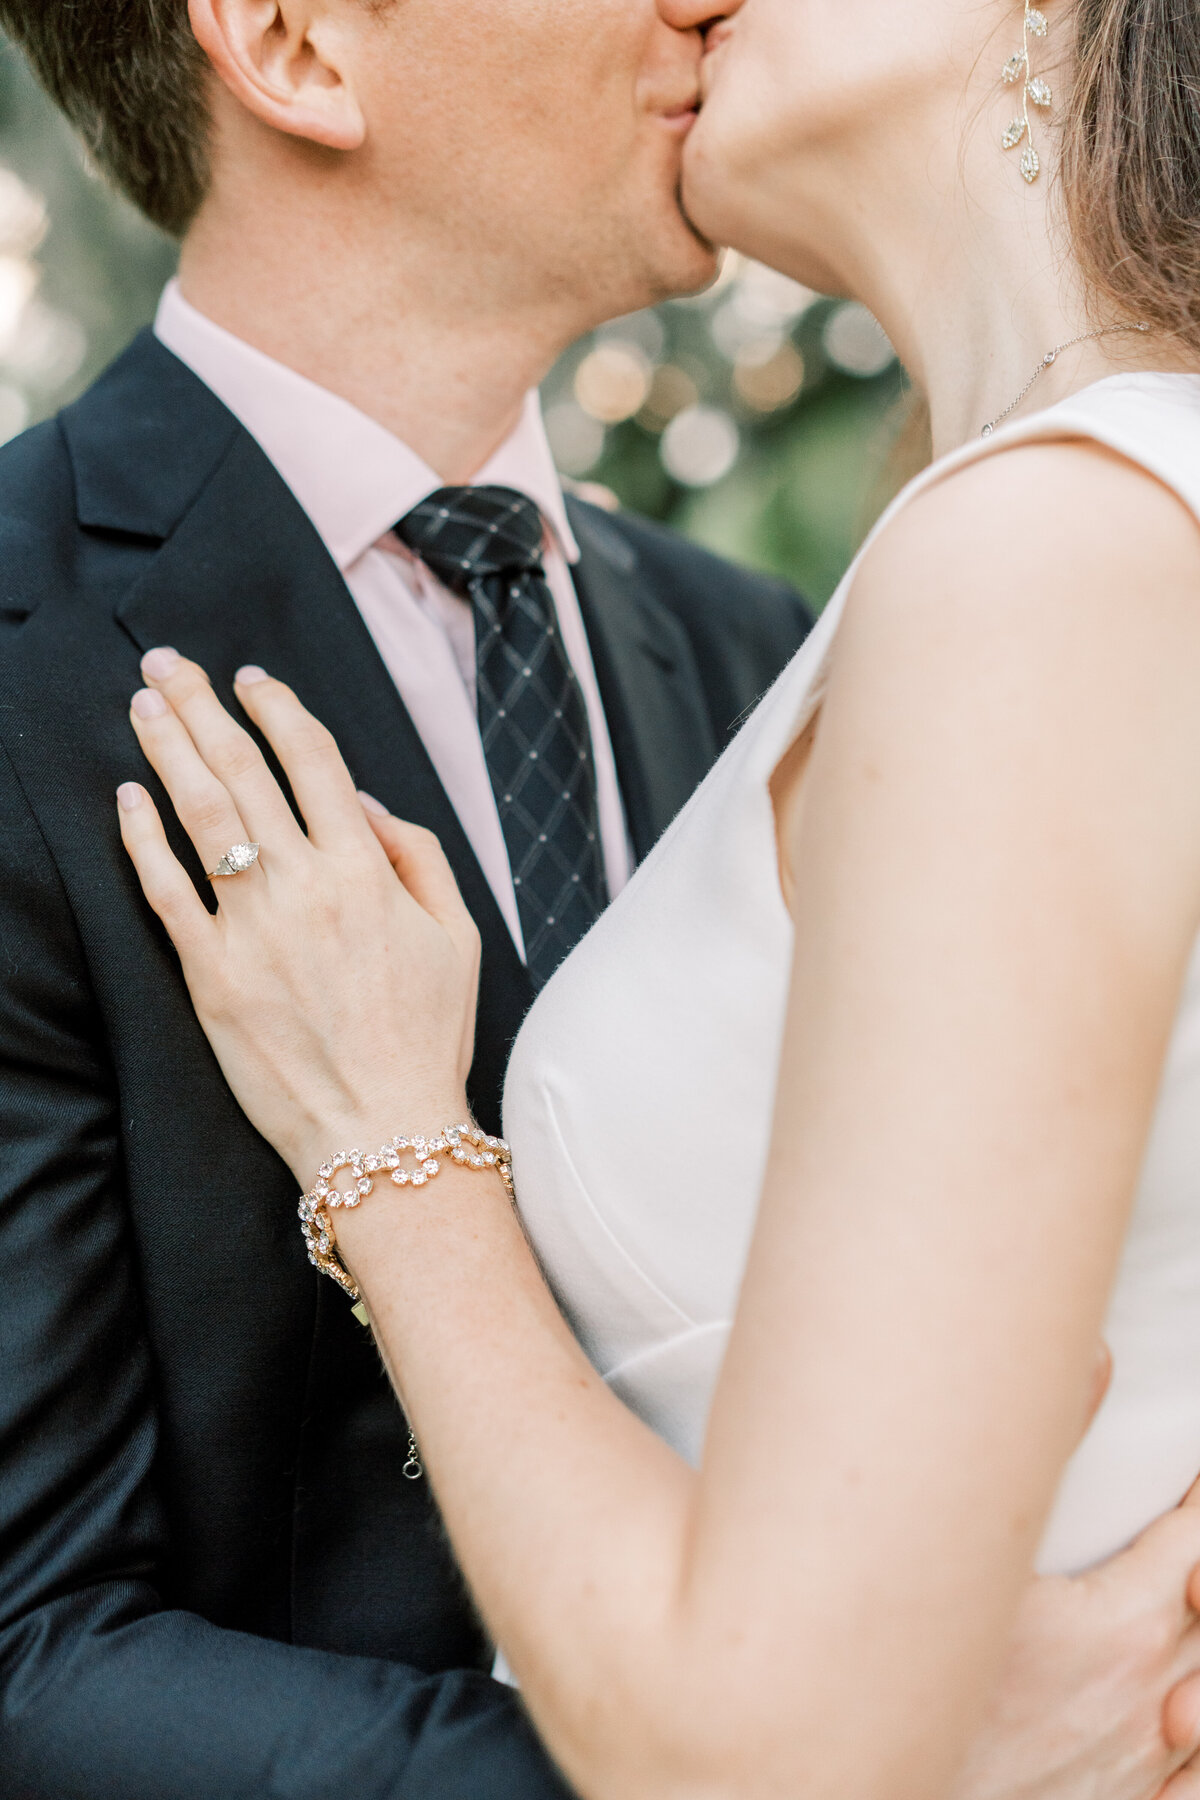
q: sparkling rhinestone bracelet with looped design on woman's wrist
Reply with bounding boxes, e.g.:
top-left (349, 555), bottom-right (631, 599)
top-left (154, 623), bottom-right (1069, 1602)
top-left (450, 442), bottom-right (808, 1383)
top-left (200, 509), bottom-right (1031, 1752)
top-left (299, 1125), bottom-right (515, 1305)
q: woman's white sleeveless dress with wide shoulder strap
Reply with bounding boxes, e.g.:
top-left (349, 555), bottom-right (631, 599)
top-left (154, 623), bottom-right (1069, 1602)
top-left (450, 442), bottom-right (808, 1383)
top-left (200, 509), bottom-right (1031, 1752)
top-left (506, 374), bottom-right (1200, 1571)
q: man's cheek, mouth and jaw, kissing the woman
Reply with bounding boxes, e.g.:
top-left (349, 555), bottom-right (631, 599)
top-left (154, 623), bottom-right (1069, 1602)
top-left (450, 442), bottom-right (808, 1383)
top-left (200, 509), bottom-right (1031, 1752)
top-left (354, 0), bottom-right (714, 329)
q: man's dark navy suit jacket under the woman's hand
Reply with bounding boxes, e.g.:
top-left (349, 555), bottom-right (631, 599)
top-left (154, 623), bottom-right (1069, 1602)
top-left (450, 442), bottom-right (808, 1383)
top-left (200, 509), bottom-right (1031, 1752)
top-left (0, 335), bottom-right (808, 1800)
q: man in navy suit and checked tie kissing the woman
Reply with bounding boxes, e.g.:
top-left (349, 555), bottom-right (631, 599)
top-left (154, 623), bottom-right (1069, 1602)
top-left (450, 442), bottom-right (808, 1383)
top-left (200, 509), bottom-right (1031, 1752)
top-left (0, 0), bottom-right (1200, 1800)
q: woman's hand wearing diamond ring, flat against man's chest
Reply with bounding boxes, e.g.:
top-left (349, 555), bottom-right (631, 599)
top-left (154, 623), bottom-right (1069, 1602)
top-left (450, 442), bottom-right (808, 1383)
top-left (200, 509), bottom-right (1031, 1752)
top-left (119, 650), bottom-right (480, 1184)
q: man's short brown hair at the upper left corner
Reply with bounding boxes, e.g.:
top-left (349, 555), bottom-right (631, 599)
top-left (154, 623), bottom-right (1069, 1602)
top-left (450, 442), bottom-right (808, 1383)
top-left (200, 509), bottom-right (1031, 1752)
top-left (0, 0), bottom-right (209, 236)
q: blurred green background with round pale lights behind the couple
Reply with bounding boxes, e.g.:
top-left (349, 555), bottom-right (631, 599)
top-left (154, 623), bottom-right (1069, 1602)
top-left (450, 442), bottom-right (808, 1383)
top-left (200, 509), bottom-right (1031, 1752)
top-left (0, 40), bottom-right (905, 605)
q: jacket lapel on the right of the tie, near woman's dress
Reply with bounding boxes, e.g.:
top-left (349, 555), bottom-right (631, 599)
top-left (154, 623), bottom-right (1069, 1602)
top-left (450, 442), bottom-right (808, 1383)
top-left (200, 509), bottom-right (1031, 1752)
top-left (569, 502), bottom-right (718, 860)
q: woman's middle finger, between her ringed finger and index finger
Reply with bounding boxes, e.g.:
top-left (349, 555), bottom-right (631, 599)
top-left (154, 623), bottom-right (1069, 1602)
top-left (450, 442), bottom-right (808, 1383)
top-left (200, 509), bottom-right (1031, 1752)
top-left (142, 648), bottom-right (302, 857)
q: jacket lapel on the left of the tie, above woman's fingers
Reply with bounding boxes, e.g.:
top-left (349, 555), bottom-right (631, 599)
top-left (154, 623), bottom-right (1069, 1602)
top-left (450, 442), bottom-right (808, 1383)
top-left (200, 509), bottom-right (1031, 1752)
top-left (63, 337), bottom-right (531, 1116)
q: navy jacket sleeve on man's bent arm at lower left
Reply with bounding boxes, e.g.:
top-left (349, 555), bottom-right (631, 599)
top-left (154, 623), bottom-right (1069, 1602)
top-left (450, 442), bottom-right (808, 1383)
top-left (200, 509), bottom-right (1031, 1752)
top-left (0, 734), bottom-right (567, 1800)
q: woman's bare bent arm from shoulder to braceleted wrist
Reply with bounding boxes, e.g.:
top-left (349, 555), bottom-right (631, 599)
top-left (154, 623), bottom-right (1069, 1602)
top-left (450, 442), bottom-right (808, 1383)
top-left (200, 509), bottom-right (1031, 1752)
top-left (116, 450), bottom-right (1200, 1800)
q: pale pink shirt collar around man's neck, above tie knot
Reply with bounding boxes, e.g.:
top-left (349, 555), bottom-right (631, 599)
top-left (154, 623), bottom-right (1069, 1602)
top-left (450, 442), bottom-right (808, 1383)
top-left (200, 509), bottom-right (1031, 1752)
top-left (155, 281), bottom-right (579, 574)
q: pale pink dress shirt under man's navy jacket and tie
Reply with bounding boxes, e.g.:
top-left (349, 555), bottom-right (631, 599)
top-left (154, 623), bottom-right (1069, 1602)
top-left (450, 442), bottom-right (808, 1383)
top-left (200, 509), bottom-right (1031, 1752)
top-left (155, 281), bottom-right (633, 956)
